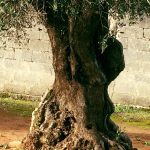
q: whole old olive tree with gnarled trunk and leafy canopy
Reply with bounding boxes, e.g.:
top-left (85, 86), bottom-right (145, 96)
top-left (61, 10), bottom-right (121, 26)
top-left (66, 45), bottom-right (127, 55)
top-left (0, 0), bottom-right (150, 150)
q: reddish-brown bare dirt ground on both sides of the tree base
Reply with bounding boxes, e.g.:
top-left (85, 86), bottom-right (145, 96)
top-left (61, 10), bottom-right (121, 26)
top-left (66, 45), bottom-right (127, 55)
top-left (0, 110), bottom-right (150, 150)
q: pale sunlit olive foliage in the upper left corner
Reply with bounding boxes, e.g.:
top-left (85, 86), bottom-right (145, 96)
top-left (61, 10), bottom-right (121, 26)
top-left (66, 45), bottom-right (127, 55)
top-left (0, 0), bottom-right (29, 30)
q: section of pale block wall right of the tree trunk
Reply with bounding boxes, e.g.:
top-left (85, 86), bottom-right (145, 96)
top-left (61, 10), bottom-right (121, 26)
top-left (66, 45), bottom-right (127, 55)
top-left (109, 18), bottom-right (150, 107)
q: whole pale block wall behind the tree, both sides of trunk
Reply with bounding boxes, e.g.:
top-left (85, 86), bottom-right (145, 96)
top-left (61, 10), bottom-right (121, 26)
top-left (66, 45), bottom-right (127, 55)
top-left (0, 19), bottom-right (150, 107)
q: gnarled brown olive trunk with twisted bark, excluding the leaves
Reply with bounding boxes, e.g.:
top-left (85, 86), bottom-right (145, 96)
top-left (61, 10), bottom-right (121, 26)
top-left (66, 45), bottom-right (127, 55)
top-left (23, 0), bottom-right (132, 150)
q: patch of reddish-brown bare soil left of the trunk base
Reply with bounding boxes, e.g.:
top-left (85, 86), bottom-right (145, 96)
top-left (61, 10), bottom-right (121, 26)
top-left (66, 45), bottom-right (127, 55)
top-left (0, 109), bottom-right (31, 145)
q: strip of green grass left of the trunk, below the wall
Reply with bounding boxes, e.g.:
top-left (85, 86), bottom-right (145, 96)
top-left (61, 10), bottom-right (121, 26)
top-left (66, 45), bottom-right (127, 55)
top-left (0, 98), bottom-right (38, 117)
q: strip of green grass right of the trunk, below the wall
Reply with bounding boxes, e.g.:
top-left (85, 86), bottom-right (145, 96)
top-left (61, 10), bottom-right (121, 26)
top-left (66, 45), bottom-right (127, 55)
top-left (112, 106), bottom-right (150, 129)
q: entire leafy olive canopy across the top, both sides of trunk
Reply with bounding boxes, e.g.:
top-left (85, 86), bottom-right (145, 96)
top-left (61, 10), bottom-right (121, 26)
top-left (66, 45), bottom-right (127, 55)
top-left (0, 0), bottom-right (150, 30)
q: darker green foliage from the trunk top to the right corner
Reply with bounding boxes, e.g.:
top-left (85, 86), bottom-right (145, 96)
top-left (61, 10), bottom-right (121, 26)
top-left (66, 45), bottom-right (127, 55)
top-left (50, 0), bottom-right (150, 20)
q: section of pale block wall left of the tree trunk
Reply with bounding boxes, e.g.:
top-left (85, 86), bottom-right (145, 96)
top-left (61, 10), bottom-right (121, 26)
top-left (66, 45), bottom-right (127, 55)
top-left (0, 25), bottom-right (55, 96)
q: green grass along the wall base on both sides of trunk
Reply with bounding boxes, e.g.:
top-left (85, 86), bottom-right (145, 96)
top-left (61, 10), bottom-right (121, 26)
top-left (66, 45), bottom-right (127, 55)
top-left (0, 98), bottom-right (150, 129)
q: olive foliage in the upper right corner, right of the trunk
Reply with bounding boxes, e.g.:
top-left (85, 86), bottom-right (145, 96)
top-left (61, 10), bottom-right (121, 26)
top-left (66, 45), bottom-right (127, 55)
top-left (108, 0), bottom-right (150, 20)
